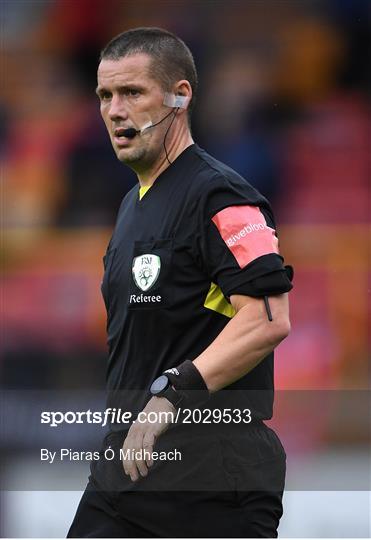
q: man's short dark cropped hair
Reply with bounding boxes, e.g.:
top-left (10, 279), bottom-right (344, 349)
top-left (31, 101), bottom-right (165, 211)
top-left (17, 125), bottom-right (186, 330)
top-left (100, 27), bottom-right (198, 120)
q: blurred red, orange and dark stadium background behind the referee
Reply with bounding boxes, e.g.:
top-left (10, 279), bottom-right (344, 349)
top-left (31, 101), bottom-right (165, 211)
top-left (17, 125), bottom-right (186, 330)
top-left (0, 0), bottom-right (371, 537)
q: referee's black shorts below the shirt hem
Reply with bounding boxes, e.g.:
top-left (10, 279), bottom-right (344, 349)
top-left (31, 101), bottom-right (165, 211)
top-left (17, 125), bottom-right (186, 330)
top-left (68, 423), bottom-right (286, 538)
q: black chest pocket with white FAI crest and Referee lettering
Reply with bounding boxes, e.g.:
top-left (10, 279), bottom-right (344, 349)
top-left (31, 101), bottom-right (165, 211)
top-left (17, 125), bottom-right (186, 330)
top-left (128, 238), bottom-right (173, 310)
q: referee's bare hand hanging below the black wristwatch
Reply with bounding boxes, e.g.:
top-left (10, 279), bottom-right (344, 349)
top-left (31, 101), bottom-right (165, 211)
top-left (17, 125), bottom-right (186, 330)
top-left (122, 396), bottom-right (176, 482)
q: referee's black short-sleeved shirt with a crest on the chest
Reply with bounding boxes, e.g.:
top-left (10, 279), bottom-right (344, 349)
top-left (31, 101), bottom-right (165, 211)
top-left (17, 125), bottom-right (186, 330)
top-left (102, 145), bottom-right (294, 419)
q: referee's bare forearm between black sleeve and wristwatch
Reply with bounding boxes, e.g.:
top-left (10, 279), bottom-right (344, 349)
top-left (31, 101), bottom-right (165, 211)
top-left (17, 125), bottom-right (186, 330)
top-left (194, 294), bottom-right (290, 393)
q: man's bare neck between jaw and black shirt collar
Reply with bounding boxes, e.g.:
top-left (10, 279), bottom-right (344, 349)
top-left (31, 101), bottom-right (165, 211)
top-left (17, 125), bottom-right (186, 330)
top-left (137, 127), bottom-right (194, 187)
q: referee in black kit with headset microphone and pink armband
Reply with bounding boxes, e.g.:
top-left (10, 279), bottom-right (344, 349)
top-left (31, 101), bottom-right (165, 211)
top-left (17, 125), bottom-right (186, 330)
top-left (69, 28), bottom-right (292, 537)
